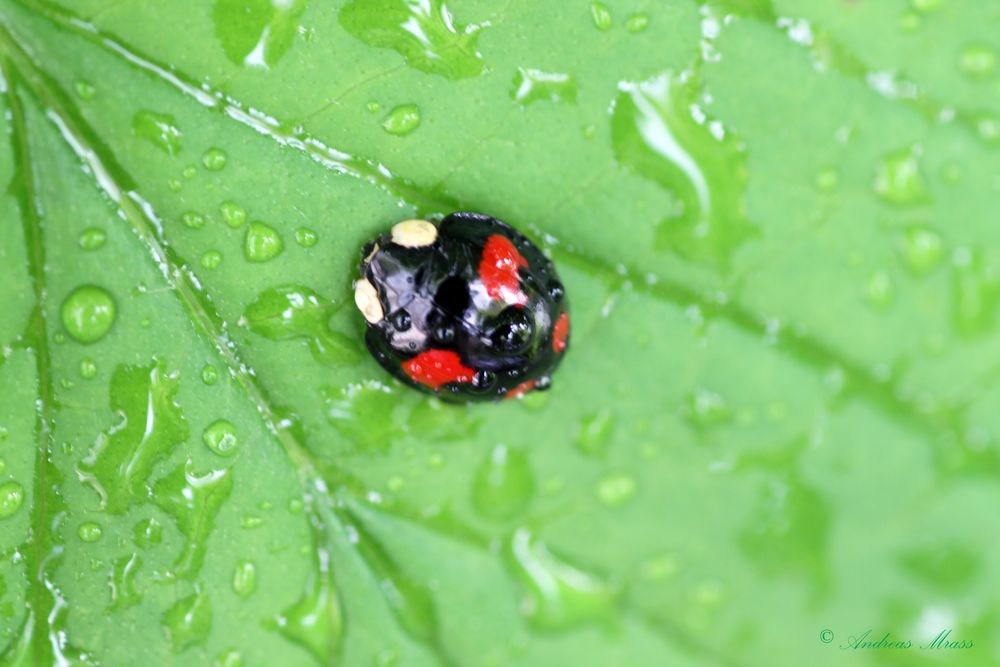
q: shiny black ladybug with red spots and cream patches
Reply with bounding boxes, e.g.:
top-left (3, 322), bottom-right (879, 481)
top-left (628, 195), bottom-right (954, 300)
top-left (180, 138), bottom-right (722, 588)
top-left (354, 212), bottom-right (569, 402)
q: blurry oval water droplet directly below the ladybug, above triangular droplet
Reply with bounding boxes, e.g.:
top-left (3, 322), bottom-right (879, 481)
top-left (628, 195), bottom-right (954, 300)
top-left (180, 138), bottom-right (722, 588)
top-left (472, 445), bottom-right (535, 520)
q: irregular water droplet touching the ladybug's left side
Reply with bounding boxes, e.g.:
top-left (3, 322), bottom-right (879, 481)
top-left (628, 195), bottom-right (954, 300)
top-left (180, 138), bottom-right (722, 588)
top-left (243, 285), bottom-right (360, 365)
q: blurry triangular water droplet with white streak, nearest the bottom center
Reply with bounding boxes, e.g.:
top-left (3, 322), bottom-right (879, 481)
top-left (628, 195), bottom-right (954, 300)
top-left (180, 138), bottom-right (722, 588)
top-left (510, 528), bottom-right (616, 630)
